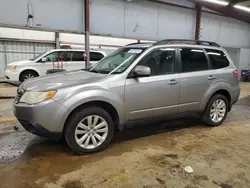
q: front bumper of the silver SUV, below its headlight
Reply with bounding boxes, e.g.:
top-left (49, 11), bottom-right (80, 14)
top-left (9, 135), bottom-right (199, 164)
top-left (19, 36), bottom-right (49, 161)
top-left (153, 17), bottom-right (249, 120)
top-left (13, 99), bottom-right (69, 140)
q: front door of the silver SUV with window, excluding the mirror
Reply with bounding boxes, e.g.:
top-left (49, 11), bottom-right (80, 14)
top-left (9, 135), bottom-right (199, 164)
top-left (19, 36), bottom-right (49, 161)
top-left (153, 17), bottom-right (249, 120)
top-left (125, 48), bottom-right (179, 121)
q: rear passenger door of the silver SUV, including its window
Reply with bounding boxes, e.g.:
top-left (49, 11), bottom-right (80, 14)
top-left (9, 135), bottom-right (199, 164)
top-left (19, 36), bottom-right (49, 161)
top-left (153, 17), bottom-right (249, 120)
top-left (179, 47), bottom-right (216, 113)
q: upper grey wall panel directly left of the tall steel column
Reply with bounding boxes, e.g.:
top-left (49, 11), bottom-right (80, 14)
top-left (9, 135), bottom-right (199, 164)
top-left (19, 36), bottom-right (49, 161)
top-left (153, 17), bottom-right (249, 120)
top-left (31, 0), bottom-right (84, 32)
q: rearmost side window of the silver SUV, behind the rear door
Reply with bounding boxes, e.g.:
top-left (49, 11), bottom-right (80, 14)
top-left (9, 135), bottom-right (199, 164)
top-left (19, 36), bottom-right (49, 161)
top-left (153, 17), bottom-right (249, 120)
top-left (206, 49), bottom-right (229, 69)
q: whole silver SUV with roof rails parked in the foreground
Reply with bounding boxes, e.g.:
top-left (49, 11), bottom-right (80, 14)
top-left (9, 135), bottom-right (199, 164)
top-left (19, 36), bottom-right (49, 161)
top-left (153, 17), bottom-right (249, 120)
top-left (14, 40), bottom-right (240, 153)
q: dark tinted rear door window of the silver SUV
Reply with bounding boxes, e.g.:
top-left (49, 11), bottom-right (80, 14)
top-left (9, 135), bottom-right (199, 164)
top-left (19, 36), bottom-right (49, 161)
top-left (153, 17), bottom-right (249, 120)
top-left (180, 48), bottom-right (208, 72)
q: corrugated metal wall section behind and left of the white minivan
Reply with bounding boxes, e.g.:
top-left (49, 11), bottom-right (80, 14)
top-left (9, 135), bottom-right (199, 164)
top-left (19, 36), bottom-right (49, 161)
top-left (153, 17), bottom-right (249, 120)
top-left (0, 41), bottom-right (55, 77)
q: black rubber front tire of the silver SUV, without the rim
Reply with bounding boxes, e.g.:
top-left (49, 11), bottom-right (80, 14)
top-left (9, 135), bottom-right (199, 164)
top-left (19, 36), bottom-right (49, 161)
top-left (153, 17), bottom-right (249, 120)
top-left (64, 107), bottom-right (114, 154)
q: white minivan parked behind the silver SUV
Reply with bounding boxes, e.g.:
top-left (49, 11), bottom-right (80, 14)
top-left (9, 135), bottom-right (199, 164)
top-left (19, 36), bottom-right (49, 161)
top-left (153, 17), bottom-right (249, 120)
top-left (4, 49), bottom-right (106, 82)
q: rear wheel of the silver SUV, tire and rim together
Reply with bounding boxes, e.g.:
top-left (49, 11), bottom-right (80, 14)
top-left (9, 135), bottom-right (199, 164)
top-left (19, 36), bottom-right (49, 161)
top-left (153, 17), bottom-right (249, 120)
top-left (202, 94), bottom-right (229, 126)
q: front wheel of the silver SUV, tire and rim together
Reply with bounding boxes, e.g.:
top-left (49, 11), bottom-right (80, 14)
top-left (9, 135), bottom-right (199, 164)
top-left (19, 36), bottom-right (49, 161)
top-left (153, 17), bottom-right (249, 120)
top-left (64, 107), bottom-right (114, 154)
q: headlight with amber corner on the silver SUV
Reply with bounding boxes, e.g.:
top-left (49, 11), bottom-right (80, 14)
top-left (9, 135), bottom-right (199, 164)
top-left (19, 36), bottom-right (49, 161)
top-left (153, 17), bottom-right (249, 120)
top-left (20, 91), bottom-right (56, 104)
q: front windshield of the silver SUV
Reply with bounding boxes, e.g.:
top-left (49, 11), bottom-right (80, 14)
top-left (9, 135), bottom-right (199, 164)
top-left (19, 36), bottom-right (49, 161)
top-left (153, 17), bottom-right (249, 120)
top-left (90, 48), bottom-right (145, 74)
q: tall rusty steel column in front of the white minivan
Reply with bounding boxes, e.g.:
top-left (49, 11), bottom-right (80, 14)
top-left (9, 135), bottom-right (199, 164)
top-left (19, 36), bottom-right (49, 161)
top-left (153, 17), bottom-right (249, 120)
top-left (84, 0), bottom-right (90, 68)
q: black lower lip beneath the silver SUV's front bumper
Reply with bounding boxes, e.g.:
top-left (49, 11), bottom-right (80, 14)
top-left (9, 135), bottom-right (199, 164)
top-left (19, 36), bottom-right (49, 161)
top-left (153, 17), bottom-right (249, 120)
top-left (18, 119), bottom-right (62, 141)
